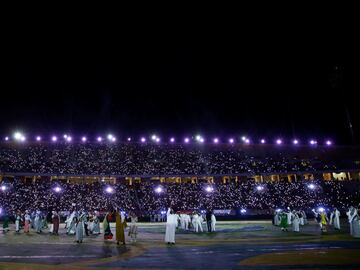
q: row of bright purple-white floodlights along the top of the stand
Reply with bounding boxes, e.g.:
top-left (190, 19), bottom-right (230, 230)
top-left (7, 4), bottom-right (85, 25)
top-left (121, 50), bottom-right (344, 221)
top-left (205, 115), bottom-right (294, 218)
top-left (5, 132), bottom-right (333, 146)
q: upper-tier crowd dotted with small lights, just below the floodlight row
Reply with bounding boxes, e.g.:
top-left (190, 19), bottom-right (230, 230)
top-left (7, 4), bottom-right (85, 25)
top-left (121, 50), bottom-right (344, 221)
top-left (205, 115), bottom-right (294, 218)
top-left (0, 143), bottom-right (360, 176)
